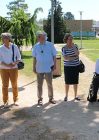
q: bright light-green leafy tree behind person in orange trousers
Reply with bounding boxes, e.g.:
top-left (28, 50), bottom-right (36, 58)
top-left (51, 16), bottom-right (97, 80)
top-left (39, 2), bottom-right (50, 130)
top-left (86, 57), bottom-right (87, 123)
top-left (9, 9), bottom-right (28, 46)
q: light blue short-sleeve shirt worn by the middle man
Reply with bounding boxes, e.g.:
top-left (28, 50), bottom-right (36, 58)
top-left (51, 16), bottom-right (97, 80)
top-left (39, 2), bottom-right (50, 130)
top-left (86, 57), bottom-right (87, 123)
top-left (32, 41), bottom-right (57, 73)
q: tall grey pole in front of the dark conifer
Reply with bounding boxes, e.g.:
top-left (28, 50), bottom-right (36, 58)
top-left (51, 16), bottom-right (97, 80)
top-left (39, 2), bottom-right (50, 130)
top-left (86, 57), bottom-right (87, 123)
top-left (51, 0), bottom-right (54, 43)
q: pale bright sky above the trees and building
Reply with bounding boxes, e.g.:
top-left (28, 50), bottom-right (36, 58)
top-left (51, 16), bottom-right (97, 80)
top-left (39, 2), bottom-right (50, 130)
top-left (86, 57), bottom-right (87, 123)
top-left (0, 0), bottom-right (99, 21)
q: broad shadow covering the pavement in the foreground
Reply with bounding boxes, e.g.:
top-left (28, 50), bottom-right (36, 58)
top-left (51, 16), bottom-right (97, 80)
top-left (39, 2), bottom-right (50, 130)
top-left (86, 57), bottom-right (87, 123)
top-left (0, 100), bottom-right (99, 140)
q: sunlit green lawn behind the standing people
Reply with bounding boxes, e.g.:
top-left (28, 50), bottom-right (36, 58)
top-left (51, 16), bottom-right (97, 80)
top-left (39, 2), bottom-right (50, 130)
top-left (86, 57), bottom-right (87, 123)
top-left (21, 40), bottom-right (99, 77)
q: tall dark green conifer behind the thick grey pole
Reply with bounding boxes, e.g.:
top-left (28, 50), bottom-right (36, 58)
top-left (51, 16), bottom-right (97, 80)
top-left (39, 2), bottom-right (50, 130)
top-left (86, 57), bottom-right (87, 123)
top-left (44, 0), bottom-right (66, 43)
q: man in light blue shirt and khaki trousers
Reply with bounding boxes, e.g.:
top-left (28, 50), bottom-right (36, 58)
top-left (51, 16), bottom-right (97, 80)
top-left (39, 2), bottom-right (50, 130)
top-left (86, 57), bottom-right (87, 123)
top-left (32, 31), bottom-right (57, 105)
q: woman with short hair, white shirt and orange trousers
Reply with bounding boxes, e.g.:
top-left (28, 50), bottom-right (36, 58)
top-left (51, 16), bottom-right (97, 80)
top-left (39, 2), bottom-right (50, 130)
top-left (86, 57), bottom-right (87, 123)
top-left (0, 33), bottom-right (21, 107)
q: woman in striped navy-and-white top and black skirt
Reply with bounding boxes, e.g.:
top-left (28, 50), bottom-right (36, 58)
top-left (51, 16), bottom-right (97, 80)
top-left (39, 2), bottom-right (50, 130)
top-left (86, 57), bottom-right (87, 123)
top-left (62, 34), bottom-right (80, 101)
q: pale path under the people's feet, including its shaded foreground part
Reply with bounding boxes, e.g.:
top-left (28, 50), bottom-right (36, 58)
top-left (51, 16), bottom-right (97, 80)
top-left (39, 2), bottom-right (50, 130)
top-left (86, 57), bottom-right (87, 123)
top-left (0, 55), bottom-right (99, 140)
